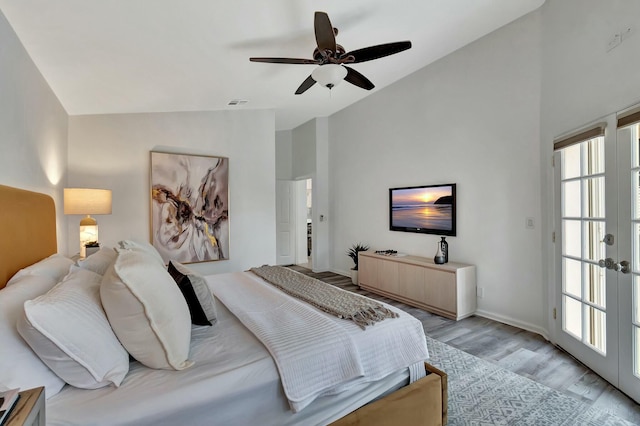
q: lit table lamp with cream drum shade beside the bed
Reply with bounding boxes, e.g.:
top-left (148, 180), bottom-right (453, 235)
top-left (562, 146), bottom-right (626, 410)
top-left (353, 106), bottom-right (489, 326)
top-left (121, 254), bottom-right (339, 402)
top-left (64, 188), bottom-right (111, 258)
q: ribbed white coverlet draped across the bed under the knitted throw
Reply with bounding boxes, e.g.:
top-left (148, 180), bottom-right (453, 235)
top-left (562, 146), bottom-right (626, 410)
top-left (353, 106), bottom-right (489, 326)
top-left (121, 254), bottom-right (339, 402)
top-left (210, 272), bottom-right (428, 412)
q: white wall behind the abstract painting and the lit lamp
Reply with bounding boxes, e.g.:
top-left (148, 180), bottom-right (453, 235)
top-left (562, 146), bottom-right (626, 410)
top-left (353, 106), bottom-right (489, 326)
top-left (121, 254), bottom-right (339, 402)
top-left (67, 110), bottom-right (276, 273)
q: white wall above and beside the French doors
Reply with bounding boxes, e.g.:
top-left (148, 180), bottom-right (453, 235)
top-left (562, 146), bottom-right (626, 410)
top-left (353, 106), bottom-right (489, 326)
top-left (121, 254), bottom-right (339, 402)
top-left (540, 0), bottom-right (640, 338)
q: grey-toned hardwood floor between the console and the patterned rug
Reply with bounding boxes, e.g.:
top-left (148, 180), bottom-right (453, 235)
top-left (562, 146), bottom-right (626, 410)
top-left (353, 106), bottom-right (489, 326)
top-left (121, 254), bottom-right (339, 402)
top-left (291, 266), bottom-right (640, 425)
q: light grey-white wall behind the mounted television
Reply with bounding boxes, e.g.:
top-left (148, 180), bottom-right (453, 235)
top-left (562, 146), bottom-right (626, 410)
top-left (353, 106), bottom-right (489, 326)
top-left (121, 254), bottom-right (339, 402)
top-left (328, 11), bottom-right (546, 334)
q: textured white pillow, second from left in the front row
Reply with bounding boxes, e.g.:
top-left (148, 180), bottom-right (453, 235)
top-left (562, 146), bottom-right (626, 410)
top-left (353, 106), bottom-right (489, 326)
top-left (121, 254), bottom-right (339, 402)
top-left (18, 267), bottom-right (129, 389)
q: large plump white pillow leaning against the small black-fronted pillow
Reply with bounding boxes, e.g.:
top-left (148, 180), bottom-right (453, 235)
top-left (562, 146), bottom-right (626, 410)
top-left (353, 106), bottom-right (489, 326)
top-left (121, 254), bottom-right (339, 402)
top-left (100, 250), bottom-right (193, 370)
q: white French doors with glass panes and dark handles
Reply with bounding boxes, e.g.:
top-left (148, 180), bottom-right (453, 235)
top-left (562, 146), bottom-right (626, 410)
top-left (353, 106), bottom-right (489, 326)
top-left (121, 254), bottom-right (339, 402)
top-left (554, 112), bottom-right (640, 401)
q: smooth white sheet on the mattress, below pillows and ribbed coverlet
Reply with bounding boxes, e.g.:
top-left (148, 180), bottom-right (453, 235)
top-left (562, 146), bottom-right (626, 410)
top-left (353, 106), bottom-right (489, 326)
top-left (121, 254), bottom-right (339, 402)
top-left (47, 274), bottom-right (424, 426)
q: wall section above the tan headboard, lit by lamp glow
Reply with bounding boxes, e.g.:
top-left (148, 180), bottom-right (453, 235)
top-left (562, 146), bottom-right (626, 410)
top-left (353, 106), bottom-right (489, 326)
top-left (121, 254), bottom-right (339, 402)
top-left (0, 12), bottom-right (67, 252)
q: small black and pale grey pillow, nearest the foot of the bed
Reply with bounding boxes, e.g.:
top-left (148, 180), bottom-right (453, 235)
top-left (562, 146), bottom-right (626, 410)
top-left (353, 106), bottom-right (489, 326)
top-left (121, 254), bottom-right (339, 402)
top-left (167, 261), bottom-right (216, 325)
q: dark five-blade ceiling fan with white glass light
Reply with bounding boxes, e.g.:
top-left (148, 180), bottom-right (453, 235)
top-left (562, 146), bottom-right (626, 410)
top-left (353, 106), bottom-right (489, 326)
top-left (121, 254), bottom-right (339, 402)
top-left (249, 12), bottom-right (411, 95)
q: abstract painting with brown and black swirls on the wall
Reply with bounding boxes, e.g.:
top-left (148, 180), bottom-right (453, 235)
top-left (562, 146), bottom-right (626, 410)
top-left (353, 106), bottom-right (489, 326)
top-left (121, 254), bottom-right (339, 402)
top-left (151, 151), bottom-right (229, 263)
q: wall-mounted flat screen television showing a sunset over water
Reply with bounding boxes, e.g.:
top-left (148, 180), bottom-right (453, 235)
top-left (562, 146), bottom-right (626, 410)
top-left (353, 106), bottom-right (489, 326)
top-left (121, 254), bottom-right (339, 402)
top-left (389, 183), bottom-right (456, 236)
